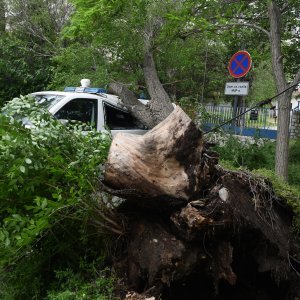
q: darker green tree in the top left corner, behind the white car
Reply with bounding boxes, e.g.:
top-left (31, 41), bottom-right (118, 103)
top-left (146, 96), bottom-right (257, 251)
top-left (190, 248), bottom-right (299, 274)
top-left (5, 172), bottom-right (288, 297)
top-left (0, 0), bottom-right (71, 106)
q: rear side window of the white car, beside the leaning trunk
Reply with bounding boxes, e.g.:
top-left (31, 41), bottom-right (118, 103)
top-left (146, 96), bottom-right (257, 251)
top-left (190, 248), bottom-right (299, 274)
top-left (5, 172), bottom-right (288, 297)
top-left (103, 102), bottom-right (146, 130)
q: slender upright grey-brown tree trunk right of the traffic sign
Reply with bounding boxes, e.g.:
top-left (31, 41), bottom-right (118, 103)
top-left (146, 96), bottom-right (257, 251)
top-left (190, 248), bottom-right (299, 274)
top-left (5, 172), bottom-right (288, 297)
top-left (268, 1), bottom-right (290, 181)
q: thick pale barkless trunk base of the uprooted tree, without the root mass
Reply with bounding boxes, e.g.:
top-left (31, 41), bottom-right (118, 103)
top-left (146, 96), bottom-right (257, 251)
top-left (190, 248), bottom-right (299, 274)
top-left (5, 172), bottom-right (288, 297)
top-left (105, 106), bottom-right (217, 200)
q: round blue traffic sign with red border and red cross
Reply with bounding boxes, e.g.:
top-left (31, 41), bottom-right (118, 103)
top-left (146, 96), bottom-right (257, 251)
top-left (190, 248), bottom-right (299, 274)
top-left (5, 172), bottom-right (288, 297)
top-left (228, 51), bottom-right (252, 78)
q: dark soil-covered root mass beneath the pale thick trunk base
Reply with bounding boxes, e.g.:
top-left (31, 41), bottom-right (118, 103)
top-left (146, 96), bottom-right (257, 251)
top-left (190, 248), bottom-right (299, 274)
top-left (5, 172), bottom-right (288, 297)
top-left (110, 167), bottom-right (300, 300)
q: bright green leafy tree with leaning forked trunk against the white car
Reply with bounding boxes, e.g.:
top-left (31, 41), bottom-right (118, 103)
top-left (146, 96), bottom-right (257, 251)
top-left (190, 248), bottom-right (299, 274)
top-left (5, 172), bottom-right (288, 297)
top-left (61, 0), bottom-right (230, 127)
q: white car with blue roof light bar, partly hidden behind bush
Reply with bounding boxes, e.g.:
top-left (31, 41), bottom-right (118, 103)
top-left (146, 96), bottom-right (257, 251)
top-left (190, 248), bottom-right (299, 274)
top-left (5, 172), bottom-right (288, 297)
top-left (31, 87), bottom-right (148, 135)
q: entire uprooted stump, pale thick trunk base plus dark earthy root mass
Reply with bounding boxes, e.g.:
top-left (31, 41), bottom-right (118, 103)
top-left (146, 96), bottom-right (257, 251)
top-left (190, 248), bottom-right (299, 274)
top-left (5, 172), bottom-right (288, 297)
top-left (104, 107), bottom-right (300, 300)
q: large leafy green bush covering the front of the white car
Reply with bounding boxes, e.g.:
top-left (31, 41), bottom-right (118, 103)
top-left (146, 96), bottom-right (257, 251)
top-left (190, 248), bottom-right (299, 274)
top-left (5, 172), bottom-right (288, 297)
top-left (0, 97), bottom-right (109, 261)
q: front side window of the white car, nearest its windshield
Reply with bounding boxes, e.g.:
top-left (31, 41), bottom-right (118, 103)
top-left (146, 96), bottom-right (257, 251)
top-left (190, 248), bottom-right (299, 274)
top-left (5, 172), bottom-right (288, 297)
top-left (54, 99), bottom-right (97, 128)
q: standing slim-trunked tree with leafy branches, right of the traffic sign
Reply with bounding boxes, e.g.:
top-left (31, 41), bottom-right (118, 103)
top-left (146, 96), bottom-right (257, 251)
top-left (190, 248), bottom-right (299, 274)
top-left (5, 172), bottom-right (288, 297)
top-left (183, 0), bottom-right (300, 180)
